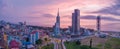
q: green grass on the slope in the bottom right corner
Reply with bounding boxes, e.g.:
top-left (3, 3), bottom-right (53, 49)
top-left (96, 37), bottom-right (120, 49)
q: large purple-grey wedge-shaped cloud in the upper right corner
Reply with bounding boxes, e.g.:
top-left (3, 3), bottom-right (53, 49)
top-left (89, 0), bottom-right (120, 16)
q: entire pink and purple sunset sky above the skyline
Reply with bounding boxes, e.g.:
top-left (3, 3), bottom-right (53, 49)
top-left (0, 0), bottom-right (120, 31)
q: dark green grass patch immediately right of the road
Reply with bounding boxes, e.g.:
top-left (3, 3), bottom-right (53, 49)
top-left (65, 42), bottom-right (96, 49)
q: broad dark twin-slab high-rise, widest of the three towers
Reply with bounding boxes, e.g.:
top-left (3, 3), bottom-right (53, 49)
top-left (72, 9), bottom-right (80, 35)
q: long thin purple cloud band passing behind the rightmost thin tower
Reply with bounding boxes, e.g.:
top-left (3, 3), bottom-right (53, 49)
top-left (80, 15), bottom-right (120, 21)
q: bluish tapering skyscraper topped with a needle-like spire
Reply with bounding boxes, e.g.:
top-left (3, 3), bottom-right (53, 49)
top-left (54, 9), bottom-right (60, 35)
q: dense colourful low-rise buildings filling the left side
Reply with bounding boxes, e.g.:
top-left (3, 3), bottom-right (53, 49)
top-left (0, 21), bottom-right (48, 49)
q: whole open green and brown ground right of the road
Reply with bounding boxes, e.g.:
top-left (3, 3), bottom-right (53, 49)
top-left (65, 36), bottom-right (120, 49)
